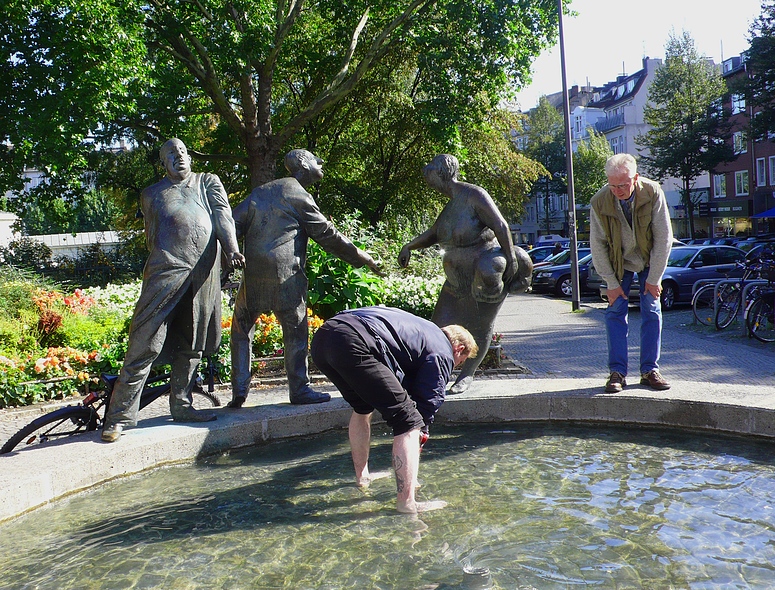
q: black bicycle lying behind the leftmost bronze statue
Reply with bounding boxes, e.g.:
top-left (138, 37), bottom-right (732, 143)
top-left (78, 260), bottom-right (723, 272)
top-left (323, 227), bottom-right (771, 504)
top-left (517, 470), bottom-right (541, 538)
top-left (0, 357), bottom-right (221, 454)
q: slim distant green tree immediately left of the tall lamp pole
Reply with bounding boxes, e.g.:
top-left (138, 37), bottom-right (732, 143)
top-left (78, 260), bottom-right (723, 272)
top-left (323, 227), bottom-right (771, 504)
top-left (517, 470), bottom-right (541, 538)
top-left (525, 96), bottom-right (567, 233)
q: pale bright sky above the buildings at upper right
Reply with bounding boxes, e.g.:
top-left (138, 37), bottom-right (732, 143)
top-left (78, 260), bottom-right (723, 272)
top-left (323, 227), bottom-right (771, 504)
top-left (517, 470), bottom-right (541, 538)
top-left (517, 0), bottom-right (761, 111)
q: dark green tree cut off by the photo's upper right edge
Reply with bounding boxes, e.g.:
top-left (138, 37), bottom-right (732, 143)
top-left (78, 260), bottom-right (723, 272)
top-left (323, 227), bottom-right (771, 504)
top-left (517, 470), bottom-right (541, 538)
top-left (731, 0), bottom-right (775, 139)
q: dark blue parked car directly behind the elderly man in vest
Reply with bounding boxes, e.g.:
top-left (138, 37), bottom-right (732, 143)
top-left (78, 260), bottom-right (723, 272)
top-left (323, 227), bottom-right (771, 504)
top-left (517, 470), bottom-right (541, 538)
top-left (587, 245), bottom-right (745, 311)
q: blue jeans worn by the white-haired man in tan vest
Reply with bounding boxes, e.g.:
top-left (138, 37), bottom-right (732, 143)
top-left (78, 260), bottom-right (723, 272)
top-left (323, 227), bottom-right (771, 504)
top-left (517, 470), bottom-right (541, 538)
top-left (605, 268), bottom-right (662, 375)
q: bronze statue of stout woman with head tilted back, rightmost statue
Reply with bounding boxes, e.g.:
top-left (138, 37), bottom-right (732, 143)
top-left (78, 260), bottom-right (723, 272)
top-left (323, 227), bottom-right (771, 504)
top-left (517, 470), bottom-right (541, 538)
top-left (398, 154), bottom-right (533, 394)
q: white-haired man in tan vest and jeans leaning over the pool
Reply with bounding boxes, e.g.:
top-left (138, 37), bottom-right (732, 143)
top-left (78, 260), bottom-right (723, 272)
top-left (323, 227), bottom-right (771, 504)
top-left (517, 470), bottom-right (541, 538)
top-left (590, 154), bottom-right (673, 393)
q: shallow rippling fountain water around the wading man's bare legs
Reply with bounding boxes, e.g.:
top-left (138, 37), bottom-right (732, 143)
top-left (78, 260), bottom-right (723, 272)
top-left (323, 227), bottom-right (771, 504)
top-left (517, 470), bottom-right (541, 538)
top-left (0, 424), bottom-right (775, 590)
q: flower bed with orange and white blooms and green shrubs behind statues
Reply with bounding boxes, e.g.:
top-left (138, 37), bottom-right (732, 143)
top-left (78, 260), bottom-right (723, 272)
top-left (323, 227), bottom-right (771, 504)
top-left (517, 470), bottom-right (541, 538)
top-left (0, 217), bottom-right (454, 407)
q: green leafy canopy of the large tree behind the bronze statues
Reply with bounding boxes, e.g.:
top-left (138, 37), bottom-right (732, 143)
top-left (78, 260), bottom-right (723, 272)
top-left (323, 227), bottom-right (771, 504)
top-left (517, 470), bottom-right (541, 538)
top-left (0, 0), bottom-right (557, 228)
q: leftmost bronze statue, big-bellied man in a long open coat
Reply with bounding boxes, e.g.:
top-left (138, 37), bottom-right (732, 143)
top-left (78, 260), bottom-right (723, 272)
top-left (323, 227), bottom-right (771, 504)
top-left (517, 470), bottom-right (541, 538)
top-left (102, 139), bottom-right (245, 442)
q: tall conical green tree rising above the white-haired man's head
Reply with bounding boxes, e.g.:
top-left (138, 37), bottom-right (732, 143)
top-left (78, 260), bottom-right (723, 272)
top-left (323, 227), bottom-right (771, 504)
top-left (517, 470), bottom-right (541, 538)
top-left (636, 31), bottom-right (734, 235)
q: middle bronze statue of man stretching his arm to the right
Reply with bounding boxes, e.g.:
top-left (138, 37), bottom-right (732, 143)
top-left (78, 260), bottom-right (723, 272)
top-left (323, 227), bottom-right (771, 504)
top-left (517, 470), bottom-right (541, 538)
top-left (228, 150), bottom-right (384, 408)
